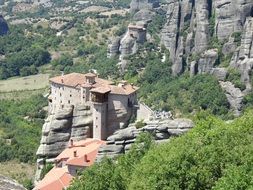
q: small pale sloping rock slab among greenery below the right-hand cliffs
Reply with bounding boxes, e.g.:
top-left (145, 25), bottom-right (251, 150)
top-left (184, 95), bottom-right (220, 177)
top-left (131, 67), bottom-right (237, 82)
top-left (220, 82), bottom-right (244, 116)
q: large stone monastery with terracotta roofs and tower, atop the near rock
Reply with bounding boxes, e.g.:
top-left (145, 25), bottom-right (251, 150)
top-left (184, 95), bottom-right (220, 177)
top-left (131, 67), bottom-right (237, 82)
top-left (49, 73), bottom-right (138, 140)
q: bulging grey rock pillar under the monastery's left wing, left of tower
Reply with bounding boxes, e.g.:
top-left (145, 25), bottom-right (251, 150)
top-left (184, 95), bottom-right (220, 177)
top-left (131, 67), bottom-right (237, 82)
top-left (37, 105), bottom-right (93, 158)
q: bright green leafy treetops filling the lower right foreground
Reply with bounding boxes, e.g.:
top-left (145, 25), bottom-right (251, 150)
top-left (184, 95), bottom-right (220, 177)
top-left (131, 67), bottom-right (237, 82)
top-left (70, 112), bottom-right (253, 190)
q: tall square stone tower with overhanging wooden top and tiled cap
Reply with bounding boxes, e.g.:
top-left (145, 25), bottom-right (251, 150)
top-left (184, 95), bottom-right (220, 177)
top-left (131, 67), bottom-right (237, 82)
top-left (90, 87), bottom-right (111, 140)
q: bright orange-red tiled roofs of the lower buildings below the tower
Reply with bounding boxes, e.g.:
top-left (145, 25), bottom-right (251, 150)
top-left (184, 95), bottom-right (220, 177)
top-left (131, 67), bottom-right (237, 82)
top-left (35, 138), bottom-right (105, 190)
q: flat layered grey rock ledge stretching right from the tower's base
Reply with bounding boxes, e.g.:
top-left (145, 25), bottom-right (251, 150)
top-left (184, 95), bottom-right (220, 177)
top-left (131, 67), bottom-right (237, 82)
top-left (97, 119), bottom-right (194, 161)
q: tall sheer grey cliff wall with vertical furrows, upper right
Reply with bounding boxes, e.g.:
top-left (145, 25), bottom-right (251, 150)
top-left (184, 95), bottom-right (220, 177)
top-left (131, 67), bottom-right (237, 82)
top-left (161, 0), bottom-right (253, 75)
